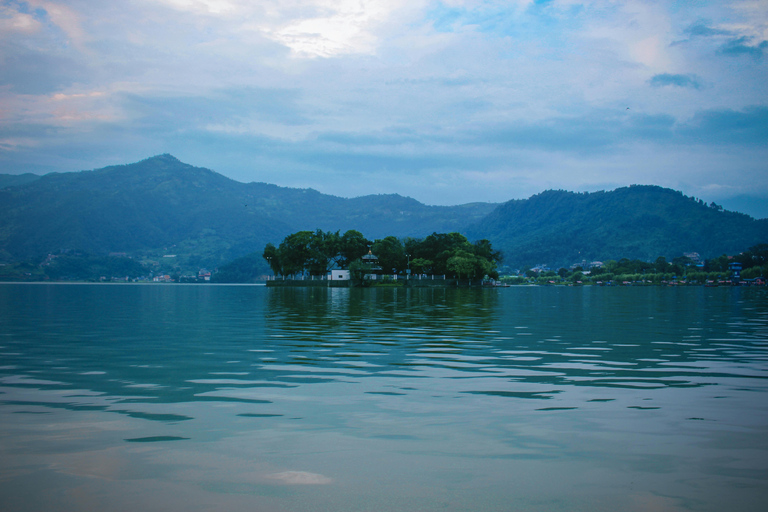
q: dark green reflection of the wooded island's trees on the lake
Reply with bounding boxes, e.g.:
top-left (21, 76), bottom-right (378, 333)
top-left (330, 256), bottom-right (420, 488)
top-left (266, 288), bottom-right (497, 373)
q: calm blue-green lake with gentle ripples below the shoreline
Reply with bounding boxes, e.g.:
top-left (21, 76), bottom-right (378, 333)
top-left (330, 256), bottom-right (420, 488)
top-left (0, 284), bottom-right (768, 512)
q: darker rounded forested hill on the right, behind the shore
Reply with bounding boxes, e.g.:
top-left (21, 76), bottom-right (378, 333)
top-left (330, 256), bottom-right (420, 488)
top-left (467, 185), bottom-right (768, 267)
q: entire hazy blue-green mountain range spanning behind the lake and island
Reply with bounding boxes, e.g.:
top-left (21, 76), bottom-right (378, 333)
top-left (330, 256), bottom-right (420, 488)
top-left (0, 155), bottom-right (768, 267)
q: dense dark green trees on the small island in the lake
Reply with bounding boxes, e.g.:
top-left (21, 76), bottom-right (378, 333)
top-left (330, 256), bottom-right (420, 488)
top-left (262, 229), bottom-right (501, 279)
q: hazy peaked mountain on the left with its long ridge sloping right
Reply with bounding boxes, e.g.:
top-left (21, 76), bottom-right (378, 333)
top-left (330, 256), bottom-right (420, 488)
top-left (0, 155), bottom-right (496, 266)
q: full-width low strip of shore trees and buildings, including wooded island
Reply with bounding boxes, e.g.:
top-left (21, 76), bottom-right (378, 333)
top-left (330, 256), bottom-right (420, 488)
top-left (0, 229), bottom-right (768, 287)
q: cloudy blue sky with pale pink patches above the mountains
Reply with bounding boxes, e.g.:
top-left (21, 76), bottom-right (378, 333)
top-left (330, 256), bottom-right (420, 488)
top-left (0, 0), bottom-right (768, 217)
